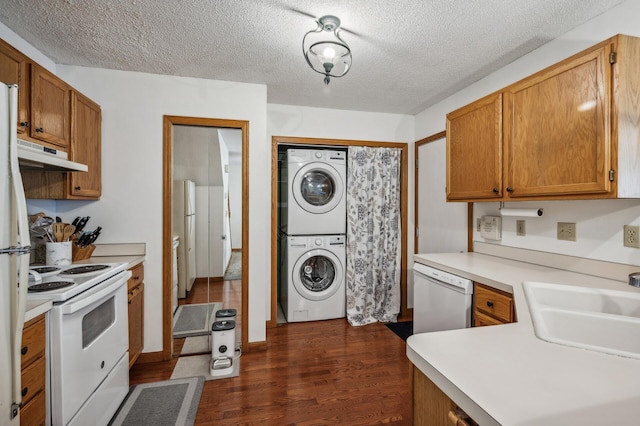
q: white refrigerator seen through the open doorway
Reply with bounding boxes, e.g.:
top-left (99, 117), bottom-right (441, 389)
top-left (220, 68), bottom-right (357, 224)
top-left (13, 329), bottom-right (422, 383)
top-left (173, 180), bottom-right (196, 298)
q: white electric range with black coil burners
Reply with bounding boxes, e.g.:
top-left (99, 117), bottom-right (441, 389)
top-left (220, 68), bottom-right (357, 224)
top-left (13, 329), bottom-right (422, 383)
top-left (28, 263), bottom-right (131, 425)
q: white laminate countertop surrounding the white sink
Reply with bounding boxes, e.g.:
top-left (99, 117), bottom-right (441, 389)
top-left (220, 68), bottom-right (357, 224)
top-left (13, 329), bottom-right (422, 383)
top-left (407, 253), bottom-right (640, 426)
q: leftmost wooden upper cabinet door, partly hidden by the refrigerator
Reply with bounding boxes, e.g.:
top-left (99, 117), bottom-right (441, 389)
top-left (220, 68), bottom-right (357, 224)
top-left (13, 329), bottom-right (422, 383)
top-left (0, 40), bottom-right (30, 133)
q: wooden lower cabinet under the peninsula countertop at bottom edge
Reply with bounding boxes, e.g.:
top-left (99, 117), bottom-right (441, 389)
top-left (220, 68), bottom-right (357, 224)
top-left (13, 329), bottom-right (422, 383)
top-left (412, 366), bottom-right (477, 426)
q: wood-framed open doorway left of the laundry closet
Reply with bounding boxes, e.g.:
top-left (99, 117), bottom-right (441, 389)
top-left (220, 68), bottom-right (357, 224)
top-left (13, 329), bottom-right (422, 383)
top-left (163, 116), bottom-right (249, 359)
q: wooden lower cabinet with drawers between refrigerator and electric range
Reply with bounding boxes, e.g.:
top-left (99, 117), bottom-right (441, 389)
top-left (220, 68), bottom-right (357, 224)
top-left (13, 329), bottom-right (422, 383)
top-left (20, 314), bottom-right (47, 426)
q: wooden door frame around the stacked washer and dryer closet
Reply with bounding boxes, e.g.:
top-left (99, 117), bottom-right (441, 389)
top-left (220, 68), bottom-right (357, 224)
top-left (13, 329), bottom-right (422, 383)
top-left (267, 136), bottom-right (413, 328)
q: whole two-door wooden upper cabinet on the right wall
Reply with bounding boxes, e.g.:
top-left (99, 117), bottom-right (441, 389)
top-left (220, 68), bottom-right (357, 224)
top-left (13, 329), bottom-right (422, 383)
top-left (447, 35), bottom-right (640, 201)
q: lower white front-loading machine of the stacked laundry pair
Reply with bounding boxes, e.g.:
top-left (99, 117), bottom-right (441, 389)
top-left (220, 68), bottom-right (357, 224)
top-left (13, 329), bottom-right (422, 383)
top-left (280, 235), bottom-right (346, 322)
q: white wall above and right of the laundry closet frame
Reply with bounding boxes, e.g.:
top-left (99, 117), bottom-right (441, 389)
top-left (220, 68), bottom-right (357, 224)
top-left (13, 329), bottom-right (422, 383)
top-left (265, 104), bottom-right (415, 314)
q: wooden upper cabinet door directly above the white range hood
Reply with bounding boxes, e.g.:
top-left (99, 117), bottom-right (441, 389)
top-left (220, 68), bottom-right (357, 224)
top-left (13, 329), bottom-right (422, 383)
top-left (30, 64), bottom-right (69, 149)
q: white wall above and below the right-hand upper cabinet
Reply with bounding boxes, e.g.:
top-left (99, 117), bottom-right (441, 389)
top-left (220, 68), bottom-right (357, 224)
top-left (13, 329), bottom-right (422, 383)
top-left (415, 0), bottom-right (640, 265)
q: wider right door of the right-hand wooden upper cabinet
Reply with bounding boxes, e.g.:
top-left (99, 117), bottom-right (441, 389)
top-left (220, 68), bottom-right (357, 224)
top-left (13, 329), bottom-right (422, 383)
top-left (504, 44), bottom-right (611, 197)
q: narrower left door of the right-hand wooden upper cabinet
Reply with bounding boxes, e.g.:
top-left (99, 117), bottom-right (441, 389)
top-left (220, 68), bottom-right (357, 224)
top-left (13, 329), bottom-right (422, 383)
top-left (447, 93), bottom-right (502, 201)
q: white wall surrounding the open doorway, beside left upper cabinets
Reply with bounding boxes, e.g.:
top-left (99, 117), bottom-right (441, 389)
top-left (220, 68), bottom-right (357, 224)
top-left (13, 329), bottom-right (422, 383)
top-left (50, 65), bottom-right (270, 352)
